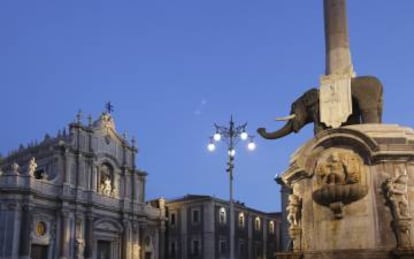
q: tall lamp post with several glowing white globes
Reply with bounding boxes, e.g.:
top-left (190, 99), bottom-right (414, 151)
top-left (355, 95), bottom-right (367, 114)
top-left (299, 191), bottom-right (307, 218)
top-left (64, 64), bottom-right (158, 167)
top-left (207, 116), bottom-right (256, 259)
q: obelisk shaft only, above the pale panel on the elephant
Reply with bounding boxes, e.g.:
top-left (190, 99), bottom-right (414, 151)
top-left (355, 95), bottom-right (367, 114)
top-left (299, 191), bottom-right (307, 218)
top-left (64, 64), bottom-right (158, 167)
top-left (324, 0), bottom-right (353, 75)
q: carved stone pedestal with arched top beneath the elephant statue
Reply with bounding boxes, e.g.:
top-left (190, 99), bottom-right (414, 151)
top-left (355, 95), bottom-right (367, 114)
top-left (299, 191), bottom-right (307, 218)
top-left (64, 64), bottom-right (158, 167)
top-left (278, 124), bottom-right (414, 259)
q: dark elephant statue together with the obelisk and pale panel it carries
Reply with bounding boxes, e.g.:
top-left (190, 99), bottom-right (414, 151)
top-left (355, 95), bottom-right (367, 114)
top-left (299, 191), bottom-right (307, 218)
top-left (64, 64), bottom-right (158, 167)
top-left (257, 0), bottom-right (383, 139)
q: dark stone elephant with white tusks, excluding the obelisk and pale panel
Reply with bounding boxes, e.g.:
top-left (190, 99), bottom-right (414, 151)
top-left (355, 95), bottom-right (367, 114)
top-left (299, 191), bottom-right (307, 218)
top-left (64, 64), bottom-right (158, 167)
top-left (257, 76), bottom-right (383, 139)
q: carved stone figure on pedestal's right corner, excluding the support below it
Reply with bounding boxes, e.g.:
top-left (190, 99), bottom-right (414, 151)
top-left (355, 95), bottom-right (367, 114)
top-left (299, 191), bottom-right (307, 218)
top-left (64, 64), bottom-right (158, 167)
top-left (384, 174), bottom-right (410, 219)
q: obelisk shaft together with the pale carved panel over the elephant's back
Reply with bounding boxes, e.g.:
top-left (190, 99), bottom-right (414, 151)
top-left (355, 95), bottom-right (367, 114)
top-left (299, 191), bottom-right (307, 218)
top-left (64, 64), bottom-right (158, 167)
top-left (319, 0), bottom-right (354, 128)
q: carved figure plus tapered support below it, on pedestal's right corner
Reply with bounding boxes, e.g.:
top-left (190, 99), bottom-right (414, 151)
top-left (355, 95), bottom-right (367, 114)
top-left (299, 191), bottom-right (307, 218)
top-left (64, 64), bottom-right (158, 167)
top-left (382, 172), bottom-right (412, 249)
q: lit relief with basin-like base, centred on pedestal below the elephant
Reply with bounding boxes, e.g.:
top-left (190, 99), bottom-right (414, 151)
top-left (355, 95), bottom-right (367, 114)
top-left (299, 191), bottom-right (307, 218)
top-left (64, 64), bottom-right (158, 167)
top-left (312, 150), bottom-right (368, 219)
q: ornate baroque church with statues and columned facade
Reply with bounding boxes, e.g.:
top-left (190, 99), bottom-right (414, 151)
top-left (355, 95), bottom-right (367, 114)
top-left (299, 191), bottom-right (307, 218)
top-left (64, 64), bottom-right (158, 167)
top-left (0, 111), bottom-right (165, 259)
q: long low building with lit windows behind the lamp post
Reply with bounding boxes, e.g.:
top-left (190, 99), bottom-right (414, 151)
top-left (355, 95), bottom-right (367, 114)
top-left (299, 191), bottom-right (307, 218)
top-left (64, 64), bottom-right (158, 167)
top-left (165, 195), bottom-right (281, 259)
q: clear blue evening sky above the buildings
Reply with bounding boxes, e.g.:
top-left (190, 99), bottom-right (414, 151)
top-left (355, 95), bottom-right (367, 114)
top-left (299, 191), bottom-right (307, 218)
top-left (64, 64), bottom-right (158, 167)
top-left (0, 0), bottom-right (414, 211)
